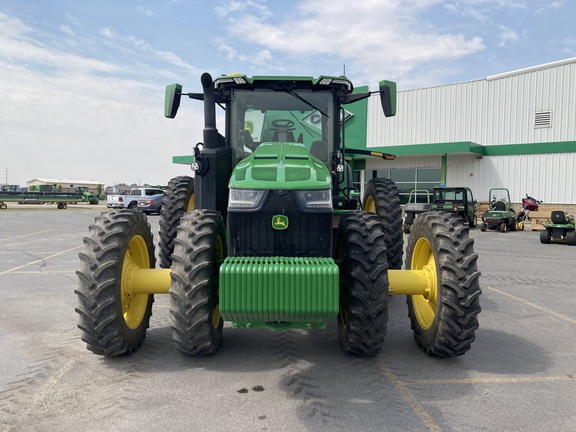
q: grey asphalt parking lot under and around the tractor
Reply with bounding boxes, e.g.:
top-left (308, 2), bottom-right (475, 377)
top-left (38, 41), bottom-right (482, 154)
top-left (0, 206), bottom-right (576, 432)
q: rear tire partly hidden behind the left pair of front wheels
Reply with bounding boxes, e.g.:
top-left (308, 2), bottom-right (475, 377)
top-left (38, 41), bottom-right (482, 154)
top-left (158, 176), bottom-right (194, 268)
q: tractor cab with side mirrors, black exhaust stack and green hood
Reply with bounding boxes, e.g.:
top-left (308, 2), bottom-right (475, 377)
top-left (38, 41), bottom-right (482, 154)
top-left (165, 74), bottom-right (396, 218)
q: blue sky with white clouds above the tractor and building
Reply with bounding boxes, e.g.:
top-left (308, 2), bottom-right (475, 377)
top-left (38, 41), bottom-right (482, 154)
top-left (0, 0), bottom-right (576, 186)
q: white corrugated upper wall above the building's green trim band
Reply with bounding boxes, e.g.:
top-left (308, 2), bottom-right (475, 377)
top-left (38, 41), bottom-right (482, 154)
top-left (367, 59), bottom-right (576, 147)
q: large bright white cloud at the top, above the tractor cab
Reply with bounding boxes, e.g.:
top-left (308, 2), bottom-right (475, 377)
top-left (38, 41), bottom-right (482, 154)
top-left (216, 0), bottom-right (484, 85)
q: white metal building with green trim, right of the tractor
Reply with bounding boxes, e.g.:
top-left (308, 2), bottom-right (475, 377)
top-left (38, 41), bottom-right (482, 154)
top-left (354, 58), bottom-right (576, 210)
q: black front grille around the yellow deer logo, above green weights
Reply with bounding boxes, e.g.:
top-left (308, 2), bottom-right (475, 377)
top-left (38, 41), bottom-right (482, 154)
top-left (228, 191), bottom-right (332, 257)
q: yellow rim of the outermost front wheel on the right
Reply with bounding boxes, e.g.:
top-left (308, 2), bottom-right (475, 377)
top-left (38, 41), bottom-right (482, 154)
top-left (411, 238), bottom-right (438, 330)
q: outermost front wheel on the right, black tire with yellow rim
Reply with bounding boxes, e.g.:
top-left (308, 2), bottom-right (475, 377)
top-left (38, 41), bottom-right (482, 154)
top-left (405, 212), bottom-right (482, 357)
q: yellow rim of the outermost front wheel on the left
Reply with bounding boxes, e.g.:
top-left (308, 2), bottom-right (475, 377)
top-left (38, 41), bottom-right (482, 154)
top-left (120, 235), bottom-right (150, 329)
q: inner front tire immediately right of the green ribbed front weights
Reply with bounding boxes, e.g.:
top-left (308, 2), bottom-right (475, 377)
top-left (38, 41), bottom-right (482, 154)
top-left (338, 212), bottom-right (388, 356)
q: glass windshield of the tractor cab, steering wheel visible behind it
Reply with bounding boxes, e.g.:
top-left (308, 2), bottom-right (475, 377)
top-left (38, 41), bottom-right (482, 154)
top-left (229, 90), bottom-right (338, 165)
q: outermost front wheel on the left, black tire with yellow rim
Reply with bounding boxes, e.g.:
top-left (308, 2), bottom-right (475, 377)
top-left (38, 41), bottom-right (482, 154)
top-left (74, 209), bottom-right (155, 357)
